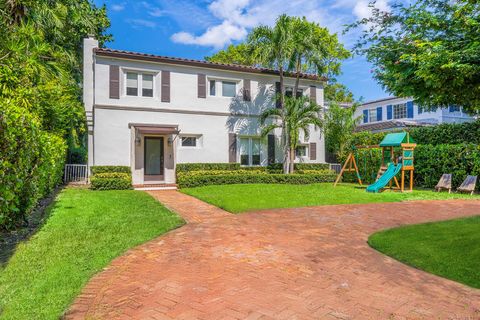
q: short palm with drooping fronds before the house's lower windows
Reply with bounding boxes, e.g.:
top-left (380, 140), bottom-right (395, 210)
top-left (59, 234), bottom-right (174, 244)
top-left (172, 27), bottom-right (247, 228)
top-left (260, 96), bottom-right (323, 173)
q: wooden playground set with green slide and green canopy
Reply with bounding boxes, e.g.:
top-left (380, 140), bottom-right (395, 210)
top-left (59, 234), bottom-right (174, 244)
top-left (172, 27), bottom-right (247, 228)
top-left (334, 132), bottom-right (417, 193)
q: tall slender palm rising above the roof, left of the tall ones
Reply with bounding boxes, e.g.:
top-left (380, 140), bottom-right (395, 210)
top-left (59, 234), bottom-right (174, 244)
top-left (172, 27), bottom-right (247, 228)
top-left (247, 14), bottom-right (295, 173)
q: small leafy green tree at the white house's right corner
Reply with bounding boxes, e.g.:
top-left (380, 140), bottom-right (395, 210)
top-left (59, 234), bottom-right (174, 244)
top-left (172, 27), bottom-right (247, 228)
top-left (324, 102), bottom-right (359, 159)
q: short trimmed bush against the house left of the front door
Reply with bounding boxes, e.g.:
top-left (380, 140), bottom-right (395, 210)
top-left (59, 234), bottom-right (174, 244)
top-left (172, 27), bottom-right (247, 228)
top-left (90, 166), bottom-right (132, 190)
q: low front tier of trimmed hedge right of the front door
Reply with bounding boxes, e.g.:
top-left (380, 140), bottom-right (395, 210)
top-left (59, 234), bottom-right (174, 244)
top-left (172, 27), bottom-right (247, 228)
top-left (177, 173), bottom-right (336, 188)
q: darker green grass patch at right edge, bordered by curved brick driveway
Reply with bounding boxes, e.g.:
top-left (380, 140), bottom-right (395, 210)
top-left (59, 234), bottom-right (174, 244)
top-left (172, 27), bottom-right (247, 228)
top-left (368, 216), bottom-right (480, 289)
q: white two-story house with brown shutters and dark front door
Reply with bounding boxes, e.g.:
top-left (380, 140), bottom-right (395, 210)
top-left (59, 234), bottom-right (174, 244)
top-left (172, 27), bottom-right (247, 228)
top-left (83, 38), bottom-right (325, 185)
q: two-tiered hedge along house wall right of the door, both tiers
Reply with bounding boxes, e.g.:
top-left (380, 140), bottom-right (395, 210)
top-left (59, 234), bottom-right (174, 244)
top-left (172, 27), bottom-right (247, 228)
top-left (177, 163), bottom-right (336, 188)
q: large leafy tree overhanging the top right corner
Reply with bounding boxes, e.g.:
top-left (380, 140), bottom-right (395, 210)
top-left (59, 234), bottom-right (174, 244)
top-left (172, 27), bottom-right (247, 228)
top-left (347, 0), bottom-right (480, 113)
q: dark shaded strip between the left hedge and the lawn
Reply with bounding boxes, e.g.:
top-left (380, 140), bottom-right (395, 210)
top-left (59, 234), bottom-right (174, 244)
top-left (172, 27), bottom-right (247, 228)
top-left (0, 185), bottom-right (65, 268)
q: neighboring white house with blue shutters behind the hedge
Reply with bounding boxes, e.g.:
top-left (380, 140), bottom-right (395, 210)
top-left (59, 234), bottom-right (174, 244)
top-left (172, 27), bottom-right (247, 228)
top-left (355, 97), bottom-right (474, 132)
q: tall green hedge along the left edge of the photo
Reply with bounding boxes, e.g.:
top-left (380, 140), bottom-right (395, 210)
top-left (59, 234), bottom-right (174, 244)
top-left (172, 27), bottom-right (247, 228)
top-left (0, 101), bottom-right (66, 229)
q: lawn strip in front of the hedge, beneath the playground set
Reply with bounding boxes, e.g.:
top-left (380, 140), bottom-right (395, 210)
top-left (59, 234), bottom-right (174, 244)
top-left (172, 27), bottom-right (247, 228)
top-left (181, 183), bottom-right (480, 213)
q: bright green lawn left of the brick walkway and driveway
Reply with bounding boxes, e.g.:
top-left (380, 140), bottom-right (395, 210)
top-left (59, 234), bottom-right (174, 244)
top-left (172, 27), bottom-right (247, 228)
top-left (0, 188), bottom-right (183, 320)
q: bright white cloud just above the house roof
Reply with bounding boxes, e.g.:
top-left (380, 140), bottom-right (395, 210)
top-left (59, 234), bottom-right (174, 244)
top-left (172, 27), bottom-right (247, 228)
top-left (172, 21), bottom-right (247, 49)
